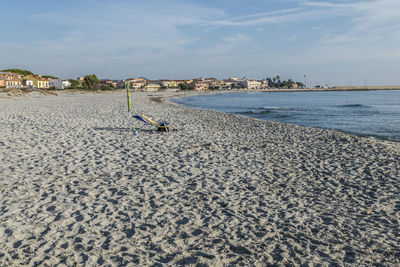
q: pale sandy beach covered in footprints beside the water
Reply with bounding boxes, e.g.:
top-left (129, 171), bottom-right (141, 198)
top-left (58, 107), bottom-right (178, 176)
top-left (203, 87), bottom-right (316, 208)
top-left (0, 92), bottom-right (400, 266)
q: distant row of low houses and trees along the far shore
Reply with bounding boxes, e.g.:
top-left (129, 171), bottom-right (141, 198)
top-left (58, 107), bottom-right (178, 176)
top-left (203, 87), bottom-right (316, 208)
top-left (0, 69), bottom-right (305, 91)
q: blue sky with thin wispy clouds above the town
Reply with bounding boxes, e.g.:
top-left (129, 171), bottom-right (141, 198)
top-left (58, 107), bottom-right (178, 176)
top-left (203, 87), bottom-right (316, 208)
top-left (0, 0), bottom-right (400, 85)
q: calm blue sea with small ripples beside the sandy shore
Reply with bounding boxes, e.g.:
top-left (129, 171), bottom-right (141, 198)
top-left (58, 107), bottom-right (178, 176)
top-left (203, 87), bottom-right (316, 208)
top-left (174, 90), bottom-right (400, 142)
